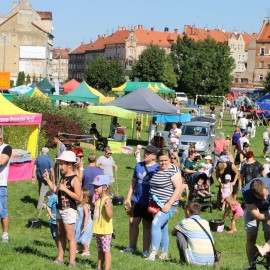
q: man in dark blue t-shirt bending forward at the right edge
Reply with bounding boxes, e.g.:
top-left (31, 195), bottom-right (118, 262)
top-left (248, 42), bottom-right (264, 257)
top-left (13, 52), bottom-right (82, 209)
top-left (242, 177), bottom-right (270, 269)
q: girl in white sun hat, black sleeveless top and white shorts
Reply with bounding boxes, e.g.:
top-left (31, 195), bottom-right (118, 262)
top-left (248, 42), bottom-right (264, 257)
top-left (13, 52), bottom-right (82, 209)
top-left (43, 151), bottom-right (81, 267)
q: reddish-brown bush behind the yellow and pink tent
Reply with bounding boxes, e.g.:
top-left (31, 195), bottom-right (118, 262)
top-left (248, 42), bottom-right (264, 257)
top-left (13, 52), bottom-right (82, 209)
top-left (41, 113), bottom-right (83, 147)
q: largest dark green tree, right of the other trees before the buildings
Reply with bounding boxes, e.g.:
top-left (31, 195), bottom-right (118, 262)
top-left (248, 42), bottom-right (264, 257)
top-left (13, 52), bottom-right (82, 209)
top-left (171, 36), bottom-right (234, 98)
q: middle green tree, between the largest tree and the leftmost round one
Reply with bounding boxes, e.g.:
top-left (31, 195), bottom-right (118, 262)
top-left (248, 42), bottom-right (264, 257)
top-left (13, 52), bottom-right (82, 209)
top-left (131, 45), bottom-right (166, 82)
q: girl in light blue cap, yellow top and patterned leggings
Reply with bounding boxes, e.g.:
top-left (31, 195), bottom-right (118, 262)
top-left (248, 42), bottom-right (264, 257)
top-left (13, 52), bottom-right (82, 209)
top-left (92, 175), bottom-right (113, 270)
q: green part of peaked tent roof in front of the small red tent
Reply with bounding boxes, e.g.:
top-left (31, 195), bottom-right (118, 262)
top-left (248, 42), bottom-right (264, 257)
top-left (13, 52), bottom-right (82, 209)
top-left (49, 81), bottom-right (99, 103)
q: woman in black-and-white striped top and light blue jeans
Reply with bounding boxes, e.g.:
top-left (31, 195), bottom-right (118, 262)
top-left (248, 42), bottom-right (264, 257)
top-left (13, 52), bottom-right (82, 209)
top-left (147, 149), bottom-right (182, 261)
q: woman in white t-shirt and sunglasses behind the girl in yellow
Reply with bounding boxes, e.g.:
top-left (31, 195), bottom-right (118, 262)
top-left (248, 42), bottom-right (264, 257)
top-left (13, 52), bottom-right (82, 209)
top-left (97, 147), bottom-right (118, 183)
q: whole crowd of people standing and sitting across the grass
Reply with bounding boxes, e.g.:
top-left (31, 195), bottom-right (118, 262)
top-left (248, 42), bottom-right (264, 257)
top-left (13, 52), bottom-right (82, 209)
top-left (0, 100), bottom-right (270, 270)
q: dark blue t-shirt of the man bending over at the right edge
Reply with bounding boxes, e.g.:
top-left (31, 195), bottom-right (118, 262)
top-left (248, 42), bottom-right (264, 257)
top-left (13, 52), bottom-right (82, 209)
top-left (242, 177), bottom-right (270, 210)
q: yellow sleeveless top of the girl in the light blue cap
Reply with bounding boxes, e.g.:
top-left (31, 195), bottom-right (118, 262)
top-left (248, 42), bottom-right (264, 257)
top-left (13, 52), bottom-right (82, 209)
top-left (92, 196), bottom-right (113, 234)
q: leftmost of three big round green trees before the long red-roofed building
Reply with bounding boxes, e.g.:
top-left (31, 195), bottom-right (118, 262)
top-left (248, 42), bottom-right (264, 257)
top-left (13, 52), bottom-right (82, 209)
top-left (83, 55), bottom-right (125, 92)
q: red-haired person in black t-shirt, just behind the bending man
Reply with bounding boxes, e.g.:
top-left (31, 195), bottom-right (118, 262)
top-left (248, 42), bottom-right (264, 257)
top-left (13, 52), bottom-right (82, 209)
top-left (240, 151), bottom-right (265, 186)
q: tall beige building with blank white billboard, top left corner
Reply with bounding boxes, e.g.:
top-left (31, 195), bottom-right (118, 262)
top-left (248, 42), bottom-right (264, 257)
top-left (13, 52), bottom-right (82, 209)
top-left (0, 0), bottom-right (54, 82)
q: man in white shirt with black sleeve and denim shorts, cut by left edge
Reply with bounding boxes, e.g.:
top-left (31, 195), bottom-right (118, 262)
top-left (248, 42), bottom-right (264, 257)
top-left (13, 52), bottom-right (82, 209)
top-left (0, 126), bottom-right (12, 243)
